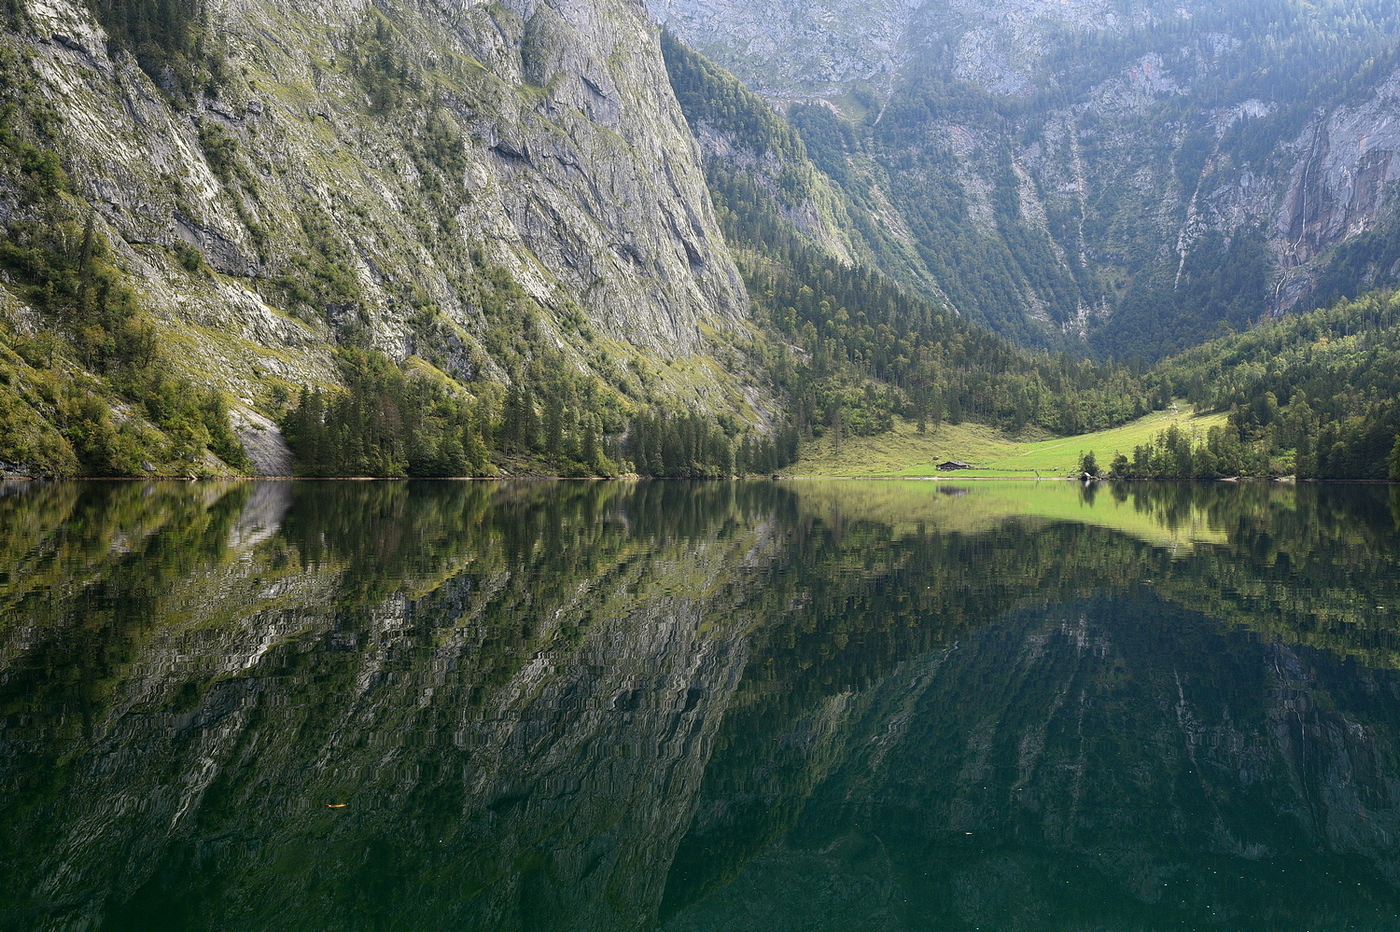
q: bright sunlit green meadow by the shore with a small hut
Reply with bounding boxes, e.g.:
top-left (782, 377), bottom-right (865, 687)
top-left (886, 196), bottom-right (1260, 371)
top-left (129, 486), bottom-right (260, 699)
top-left (785, 404), bottom-right (1225, 479)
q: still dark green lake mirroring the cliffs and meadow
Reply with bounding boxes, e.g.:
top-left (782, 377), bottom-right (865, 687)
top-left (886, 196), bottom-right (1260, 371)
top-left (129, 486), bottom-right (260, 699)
top-left (0, 481), bottom-right (1400, 932)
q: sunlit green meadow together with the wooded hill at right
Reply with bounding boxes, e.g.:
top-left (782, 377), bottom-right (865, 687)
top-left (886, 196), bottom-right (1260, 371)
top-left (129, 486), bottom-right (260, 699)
top-left (788, 291), bottom-right (1400, 480)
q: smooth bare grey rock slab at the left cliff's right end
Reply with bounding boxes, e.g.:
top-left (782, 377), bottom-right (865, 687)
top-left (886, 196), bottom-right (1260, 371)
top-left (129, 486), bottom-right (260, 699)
top-left (439, 1), bottom-right (745, 344)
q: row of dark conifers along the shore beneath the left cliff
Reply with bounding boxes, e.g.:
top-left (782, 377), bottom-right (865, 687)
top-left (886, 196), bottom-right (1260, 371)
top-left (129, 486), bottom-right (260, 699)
top-left (281, 348), bottom-right (797, 479)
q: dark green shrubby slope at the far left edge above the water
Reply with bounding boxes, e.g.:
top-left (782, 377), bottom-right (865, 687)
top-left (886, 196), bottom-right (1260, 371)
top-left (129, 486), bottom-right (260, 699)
top-left (0, 49), bottom-right (248, 476)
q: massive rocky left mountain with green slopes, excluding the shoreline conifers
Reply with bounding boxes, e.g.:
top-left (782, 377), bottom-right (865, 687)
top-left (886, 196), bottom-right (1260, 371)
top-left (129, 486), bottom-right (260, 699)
top-left (0, 0), bottom-right (774, 474)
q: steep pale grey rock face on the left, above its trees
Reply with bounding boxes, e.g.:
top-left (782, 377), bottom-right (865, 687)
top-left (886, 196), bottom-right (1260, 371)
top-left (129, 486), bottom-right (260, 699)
top-left (0, 0), bottom-right (746, 428)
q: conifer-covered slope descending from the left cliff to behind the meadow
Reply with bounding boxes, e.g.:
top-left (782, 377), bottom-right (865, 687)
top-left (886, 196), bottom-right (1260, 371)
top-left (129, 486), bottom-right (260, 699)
top-left (662, 29), bottom-right (1149, 447)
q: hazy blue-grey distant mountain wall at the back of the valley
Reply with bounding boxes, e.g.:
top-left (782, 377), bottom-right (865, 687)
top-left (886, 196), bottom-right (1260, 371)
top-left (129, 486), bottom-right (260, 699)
top-left (652, 0), bottom-right (1400, 360)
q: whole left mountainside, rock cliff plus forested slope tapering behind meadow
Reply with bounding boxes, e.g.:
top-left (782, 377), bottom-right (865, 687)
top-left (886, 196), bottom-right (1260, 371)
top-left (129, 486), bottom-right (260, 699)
top-left (0, 0), bottom-right (1176, 476)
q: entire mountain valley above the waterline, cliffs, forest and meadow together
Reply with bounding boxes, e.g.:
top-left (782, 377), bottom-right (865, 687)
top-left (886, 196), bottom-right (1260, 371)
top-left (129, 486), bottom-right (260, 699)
top-left (0, 0), bottom-right (1400, 479)
